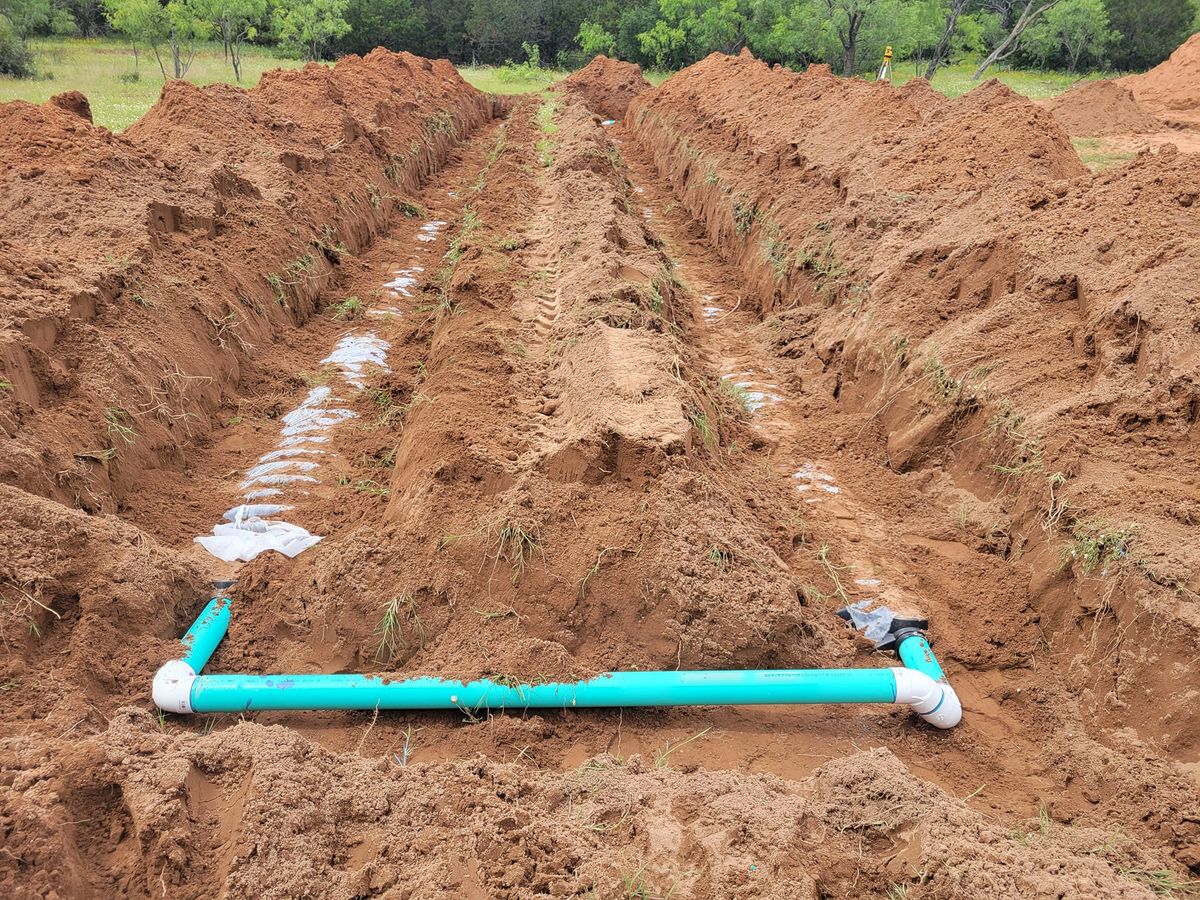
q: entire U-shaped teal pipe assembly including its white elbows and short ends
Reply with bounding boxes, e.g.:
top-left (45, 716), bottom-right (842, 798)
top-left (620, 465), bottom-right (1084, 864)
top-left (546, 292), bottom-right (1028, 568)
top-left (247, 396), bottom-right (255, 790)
top-left (154, 596), bottom-right (962, 728)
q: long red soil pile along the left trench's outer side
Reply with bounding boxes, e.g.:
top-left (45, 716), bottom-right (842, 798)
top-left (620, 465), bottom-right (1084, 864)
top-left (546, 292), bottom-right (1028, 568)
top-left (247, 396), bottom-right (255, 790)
top-left (0, 50), bottom-right (492, 511)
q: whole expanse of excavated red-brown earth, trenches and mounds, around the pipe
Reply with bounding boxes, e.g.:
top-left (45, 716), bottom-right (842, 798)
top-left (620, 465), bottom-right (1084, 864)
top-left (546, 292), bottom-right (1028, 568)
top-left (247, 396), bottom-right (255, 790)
top-left (0, 52), bottom-right (1200, 898)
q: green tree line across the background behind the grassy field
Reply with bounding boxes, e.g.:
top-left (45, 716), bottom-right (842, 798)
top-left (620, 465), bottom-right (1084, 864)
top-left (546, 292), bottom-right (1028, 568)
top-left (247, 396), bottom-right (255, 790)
top-left (0, 0), bottom-right (1200, 80)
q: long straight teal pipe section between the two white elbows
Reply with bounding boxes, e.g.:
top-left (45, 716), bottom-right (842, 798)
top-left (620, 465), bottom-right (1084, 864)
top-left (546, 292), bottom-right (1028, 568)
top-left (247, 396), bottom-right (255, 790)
top-left (190, 668), bottom-right (896, 713)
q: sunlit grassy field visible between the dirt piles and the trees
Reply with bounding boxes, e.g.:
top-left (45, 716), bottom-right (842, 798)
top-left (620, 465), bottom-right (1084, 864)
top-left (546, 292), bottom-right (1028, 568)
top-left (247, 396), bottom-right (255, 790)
top-left (0, 38), bottom-right (1100, 131)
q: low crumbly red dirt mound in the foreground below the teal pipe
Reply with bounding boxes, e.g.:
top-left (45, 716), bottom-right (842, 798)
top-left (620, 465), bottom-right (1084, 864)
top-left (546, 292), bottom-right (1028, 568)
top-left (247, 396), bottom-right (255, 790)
top-left (0, 709), bottom-right (1153, 900)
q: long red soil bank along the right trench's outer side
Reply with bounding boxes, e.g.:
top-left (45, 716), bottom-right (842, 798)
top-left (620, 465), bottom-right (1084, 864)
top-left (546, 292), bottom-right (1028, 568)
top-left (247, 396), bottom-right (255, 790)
top-left (625, 45), bottom-right (1200, 878)
